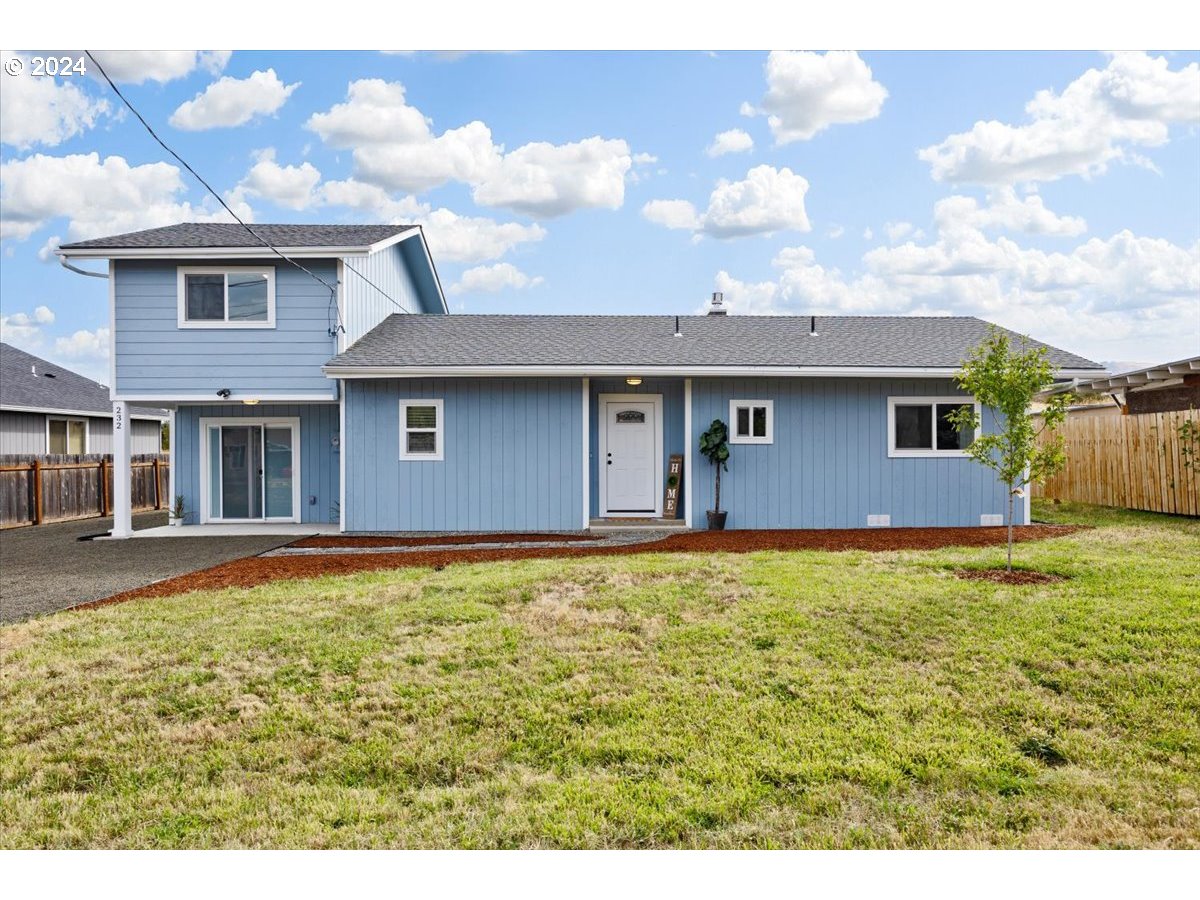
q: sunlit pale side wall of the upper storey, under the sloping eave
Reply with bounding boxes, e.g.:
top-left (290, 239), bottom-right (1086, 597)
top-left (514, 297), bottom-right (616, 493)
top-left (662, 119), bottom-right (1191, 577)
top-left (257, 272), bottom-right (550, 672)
top-left (342, 238), bottom-right (442, 347)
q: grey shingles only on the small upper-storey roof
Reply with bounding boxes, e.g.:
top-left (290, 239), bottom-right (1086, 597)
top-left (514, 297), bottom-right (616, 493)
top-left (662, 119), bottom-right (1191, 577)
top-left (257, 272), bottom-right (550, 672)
top-left (60, 222), bottom-right (416, 250)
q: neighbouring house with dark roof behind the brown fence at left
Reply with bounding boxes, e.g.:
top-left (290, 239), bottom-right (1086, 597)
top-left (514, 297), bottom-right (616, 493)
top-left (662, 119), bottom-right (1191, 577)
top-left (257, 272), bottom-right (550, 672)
top-left (0, 343), bottom-right (167, 456)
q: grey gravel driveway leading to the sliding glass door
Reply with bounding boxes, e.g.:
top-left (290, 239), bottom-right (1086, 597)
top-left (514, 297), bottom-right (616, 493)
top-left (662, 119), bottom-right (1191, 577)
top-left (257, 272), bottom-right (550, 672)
top-left (0, 512), bottom-right (295, 622)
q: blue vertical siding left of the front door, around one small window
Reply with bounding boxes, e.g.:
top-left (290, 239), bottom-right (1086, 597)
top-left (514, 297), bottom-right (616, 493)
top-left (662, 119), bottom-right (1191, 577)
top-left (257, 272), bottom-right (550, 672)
top-left (344, 378), bottom-right (583, 532)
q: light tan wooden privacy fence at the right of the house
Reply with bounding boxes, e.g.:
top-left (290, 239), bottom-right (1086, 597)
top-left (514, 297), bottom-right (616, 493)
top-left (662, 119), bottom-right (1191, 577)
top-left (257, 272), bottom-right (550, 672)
top-left (1033, 409), bottom-right (1200, 516)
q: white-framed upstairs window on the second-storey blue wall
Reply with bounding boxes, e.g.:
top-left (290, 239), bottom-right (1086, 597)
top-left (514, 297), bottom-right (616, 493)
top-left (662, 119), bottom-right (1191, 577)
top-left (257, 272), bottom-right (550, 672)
top-left (179, 265), bottom-right (275, 328)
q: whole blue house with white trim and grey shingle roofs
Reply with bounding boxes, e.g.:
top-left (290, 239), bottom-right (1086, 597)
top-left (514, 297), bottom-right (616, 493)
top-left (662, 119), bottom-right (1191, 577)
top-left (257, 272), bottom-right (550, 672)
top-left (59, 224), bottom-right (1103, 535)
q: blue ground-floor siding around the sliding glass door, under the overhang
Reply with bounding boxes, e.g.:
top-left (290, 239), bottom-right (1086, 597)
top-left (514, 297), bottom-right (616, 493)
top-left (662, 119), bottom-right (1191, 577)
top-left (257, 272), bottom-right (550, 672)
top-left (172, 403), bottom-right (341, 524)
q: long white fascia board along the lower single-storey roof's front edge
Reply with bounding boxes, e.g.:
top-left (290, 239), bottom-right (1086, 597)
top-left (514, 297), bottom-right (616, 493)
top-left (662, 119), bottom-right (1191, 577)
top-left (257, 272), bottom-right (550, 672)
top-left (322, 366), bottom-right (1094, 378)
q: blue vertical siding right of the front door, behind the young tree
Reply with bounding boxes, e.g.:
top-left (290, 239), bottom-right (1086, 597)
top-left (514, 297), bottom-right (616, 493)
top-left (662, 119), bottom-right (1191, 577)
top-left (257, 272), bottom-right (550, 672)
top-left (688, 378), bottom-right (1024, 528)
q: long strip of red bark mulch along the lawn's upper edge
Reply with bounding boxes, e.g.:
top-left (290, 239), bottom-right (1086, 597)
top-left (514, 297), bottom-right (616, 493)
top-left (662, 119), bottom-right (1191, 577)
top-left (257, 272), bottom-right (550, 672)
top-left (76, 524), bottom-right (1080, 608)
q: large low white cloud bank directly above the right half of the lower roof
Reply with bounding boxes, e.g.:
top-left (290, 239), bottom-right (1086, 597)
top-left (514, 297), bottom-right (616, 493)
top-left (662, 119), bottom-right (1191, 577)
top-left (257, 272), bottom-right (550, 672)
top-left (716, 198), bottom-right (1200, 359)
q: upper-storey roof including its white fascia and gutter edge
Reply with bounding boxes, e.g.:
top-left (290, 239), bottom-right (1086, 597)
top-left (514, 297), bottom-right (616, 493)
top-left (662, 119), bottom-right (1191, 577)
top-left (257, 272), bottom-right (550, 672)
top-left (59, 222), bottom-right (420, 258)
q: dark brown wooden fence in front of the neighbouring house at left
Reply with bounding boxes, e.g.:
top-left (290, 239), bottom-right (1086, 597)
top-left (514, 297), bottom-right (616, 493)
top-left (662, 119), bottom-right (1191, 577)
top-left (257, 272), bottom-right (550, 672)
top-left (0, 454), bottom-right (170, 528)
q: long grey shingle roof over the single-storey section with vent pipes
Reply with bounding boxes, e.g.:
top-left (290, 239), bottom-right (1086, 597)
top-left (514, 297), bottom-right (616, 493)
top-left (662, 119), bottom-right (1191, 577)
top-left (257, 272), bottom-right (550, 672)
top-left (329, 314), bottom-right (1103, 370)
